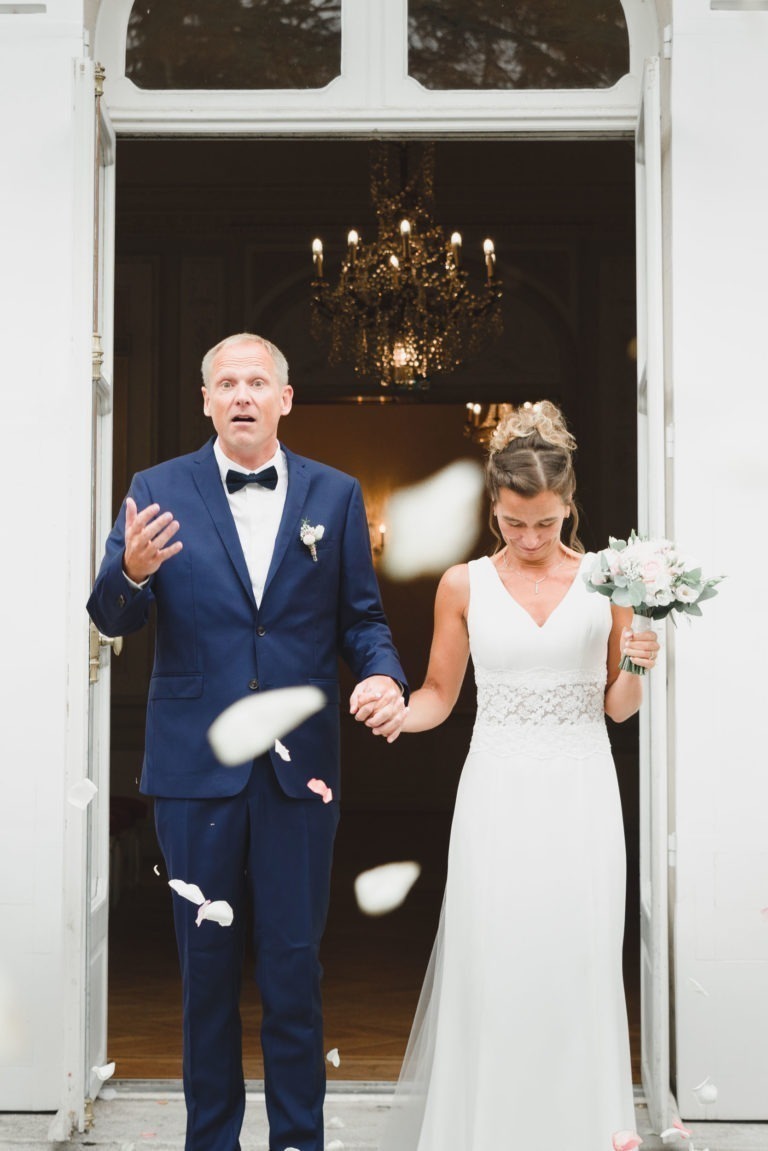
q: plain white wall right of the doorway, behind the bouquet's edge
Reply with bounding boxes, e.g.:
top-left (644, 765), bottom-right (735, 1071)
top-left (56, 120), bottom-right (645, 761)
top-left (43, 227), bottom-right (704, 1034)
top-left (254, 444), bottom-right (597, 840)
top-left (670, 0), bottom-right (768, 1119)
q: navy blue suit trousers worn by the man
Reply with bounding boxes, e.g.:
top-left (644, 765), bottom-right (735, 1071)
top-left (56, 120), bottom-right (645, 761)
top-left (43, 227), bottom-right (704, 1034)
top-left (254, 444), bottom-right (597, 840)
top-left (155, 756), bottom-right (339, 1151)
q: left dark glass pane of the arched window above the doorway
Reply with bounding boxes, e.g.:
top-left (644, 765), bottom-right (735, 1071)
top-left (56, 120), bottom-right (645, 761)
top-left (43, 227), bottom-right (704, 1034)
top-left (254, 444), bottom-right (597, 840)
top-left (126, 0), bottom-right (341, 89)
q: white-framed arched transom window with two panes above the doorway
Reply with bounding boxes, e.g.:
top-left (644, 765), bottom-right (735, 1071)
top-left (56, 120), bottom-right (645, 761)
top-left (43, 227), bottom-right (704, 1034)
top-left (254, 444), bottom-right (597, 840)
top-left (94, 0), bottom-right (659, 136)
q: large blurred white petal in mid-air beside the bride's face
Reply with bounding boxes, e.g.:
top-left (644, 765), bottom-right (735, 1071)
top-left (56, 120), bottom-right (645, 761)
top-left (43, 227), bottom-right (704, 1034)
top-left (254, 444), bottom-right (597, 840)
top-left (381, 459), bottom-right (485, 580)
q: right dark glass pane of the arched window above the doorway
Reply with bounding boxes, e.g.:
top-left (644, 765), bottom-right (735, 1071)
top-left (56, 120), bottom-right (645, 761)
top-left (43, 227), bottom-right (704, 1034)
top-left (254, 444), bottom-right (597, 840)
top-left (408, 0), bottom-right (630, 90)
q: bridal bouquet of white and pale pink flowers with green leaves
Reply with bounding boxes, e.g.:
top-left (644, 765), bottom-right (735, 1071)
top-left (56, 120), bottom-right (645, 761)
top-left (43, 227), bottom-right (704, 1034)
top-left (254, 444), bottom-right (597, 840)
top-left (584, 532), bottom-right (723, 676)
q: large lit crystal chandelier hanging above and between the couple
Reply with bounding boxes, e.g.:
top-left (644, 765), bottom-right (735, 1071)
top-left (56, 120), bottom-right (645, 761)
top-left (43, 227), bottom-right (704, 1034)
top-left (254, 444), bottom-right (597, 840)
top-left (312, 144), bottom-right (501, 390)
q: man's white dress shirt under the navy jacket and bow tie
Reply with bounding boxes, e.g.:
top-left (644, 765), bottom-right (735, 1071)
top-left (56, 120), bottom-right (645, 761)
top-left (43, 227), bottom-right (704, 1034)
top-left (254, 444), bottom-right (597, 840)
top-left (213, 440), bottom-right (288, 605)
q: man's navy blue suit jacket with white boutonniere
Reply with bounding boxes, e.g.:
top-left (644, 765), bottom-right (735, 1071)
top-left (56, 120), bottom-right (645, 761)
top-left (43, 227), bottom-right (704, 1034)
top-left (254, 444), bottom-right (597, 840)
top-left (88, 437), bottom-right (405, 799)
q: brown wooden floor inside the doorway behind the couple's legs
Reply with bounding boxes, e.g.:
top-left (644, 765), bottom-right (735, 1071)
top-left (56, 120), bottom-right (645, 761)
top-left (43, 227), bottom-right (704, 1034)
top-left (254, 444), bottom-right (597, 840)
top-left (108, 813), bottom-right (640, 1082)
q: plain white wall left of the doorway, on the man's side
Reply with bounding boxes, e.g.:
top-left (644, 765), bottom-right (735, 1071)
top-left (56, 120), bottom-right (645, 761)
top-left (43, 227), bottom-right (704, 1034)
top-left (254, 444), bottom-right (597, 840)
top-left (0, 0), bottom-right (90, 1111)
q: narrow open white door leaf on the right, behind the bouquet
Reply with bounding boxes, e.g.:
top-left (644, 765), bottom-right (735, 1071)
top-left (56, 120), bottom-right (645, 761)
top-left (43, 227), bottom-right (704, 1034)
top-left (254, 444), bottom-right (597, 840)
top-left (636, 58), bottom-right (674, 1131)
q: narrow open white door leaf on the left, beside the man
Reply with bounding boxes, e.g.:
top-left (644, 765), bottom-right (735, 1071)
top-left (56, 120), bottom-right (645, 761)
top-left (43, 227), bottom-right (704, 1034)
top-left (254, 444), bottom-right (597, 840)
top-left (48, 59), bottom-right (115, 1141)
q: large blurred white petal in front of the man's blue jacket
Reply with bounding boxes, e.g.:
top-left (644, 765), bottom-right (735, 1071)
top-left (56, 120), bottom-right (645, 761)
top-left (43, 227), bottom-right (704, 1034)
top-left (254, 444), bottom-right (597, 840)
top-left (208, 686), bottom-right (326, 768)
